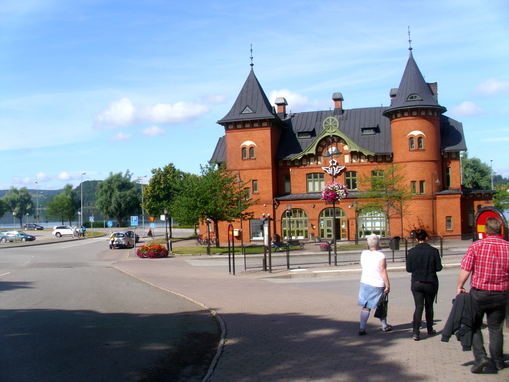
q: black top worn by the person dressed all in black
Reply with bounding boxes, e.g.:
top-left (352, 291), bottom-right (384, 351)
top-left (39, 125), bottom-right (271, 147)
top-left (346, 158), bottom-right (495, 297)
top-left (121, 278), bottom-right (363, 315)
top-left (406, 243), bottom-right (442, 283)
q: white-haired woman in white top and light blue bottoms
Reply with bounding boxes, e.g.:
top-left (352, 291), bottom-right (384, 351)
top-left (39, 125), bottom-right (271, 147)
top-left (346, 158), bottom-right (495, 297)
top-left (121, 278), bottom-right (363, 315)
top-left (358, 234), bottom-right (392, 336)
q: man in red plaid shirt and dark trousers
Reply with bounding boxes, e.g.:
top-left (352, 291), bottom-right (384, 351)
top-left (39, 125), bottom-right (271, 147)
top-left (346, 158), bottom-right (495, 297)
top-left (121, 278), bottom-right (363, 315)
top-left (458, 218), bottom-right (509, 373)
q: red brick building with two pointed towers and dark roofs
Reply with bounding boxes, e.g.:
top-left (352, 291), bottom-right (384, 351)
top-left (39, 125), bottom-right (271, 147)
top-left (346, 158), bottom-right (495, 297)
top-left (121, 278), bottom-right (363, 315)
top-left (207, 50), bottom-right (492, 242)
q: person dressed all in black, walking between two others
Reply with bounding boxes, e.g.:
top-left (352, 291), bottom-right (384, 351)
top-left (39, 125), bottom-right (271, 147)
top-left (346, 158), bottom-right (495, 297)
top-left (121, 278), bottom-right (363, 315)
top-left (406, 229), bottom-right (442, 341)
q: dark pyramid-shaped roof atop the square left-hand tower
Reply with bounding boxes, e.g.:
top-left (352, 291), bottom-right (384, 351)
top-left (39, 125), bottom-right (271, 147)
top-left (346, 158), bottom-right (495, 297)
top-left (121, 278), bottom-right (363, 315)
top-left (217, 68), bottom-right (279, 125)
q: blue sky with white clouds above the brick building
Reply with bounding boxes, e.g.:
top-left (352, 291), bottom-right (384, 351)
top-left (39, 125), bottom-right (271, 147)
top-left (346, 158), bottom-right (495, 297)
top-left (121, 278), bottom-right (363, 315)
top-left (0, 0), bottom-right (509, 190)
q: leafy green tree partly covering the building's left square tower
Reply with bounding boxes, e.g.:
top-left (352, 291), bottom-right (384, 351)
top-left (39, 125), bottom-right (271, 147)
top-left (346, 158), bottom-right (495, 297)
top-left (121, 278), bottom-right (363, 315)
top-left (175, 163), bottom-right (256, 247)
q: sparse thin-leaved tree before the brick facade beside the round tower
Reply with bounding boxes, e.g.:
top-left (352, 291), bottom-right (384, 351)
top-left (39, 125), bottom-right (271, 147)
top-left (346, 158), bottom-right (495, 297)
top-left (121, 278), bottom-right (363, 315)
top-left (358, 164), bottom-right (412, 236)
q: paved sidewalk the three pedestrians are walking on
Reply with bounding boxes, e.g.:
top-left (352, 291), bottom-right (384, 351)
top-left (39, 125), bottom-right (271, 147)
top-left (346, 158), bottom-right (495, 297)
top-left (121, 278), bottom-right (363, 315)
top-left (115, 243), bottom-right (509, 382)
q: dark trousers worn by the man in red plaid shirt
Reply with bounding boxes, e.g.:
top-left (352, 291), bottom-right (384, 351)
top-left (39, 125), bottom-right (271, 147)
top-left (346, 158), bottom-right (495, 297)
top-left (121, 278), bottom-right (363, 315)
top-left (470, 288), bottom-right (508, 362)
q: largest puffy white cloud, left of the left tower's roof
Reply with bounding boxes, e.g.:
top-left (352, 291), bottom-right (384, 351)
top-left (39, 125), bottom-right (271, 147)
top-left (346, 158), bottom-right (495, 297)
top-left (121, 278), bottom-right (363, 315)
top-left (94, 98), bottom-right (210, 130)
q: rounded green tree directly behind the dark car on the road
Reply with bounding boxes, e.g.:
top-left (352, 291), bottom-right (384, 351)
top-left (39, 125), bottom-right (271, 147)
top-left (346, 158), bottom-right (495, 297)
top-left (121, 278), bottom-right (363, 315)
top-left (97, 170), bottom-right (141, 226)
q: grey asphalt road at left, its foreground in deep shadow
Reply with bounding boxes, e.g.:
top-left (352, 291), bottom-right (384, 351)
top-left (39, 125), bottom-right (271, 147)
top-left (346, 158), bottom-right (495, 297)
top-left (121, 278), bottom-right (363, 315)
top-left (0, 238), bottom-right (219, 382)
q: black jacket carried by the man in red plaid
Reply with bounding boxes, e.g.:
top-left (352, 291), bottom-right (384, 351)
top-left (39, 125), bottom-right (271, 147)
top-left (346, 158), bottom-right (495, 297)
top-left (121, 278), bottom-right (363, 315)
top-left (442, 293), bottom-right (474, 351)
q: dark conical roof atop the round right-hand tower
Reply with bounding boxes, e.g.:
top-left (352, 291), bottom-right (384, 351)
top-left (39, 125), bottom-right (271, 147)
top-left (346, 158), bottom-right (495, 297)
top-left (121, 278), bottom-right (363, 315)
top-left (384, 51), bottom-right (447, 115)
